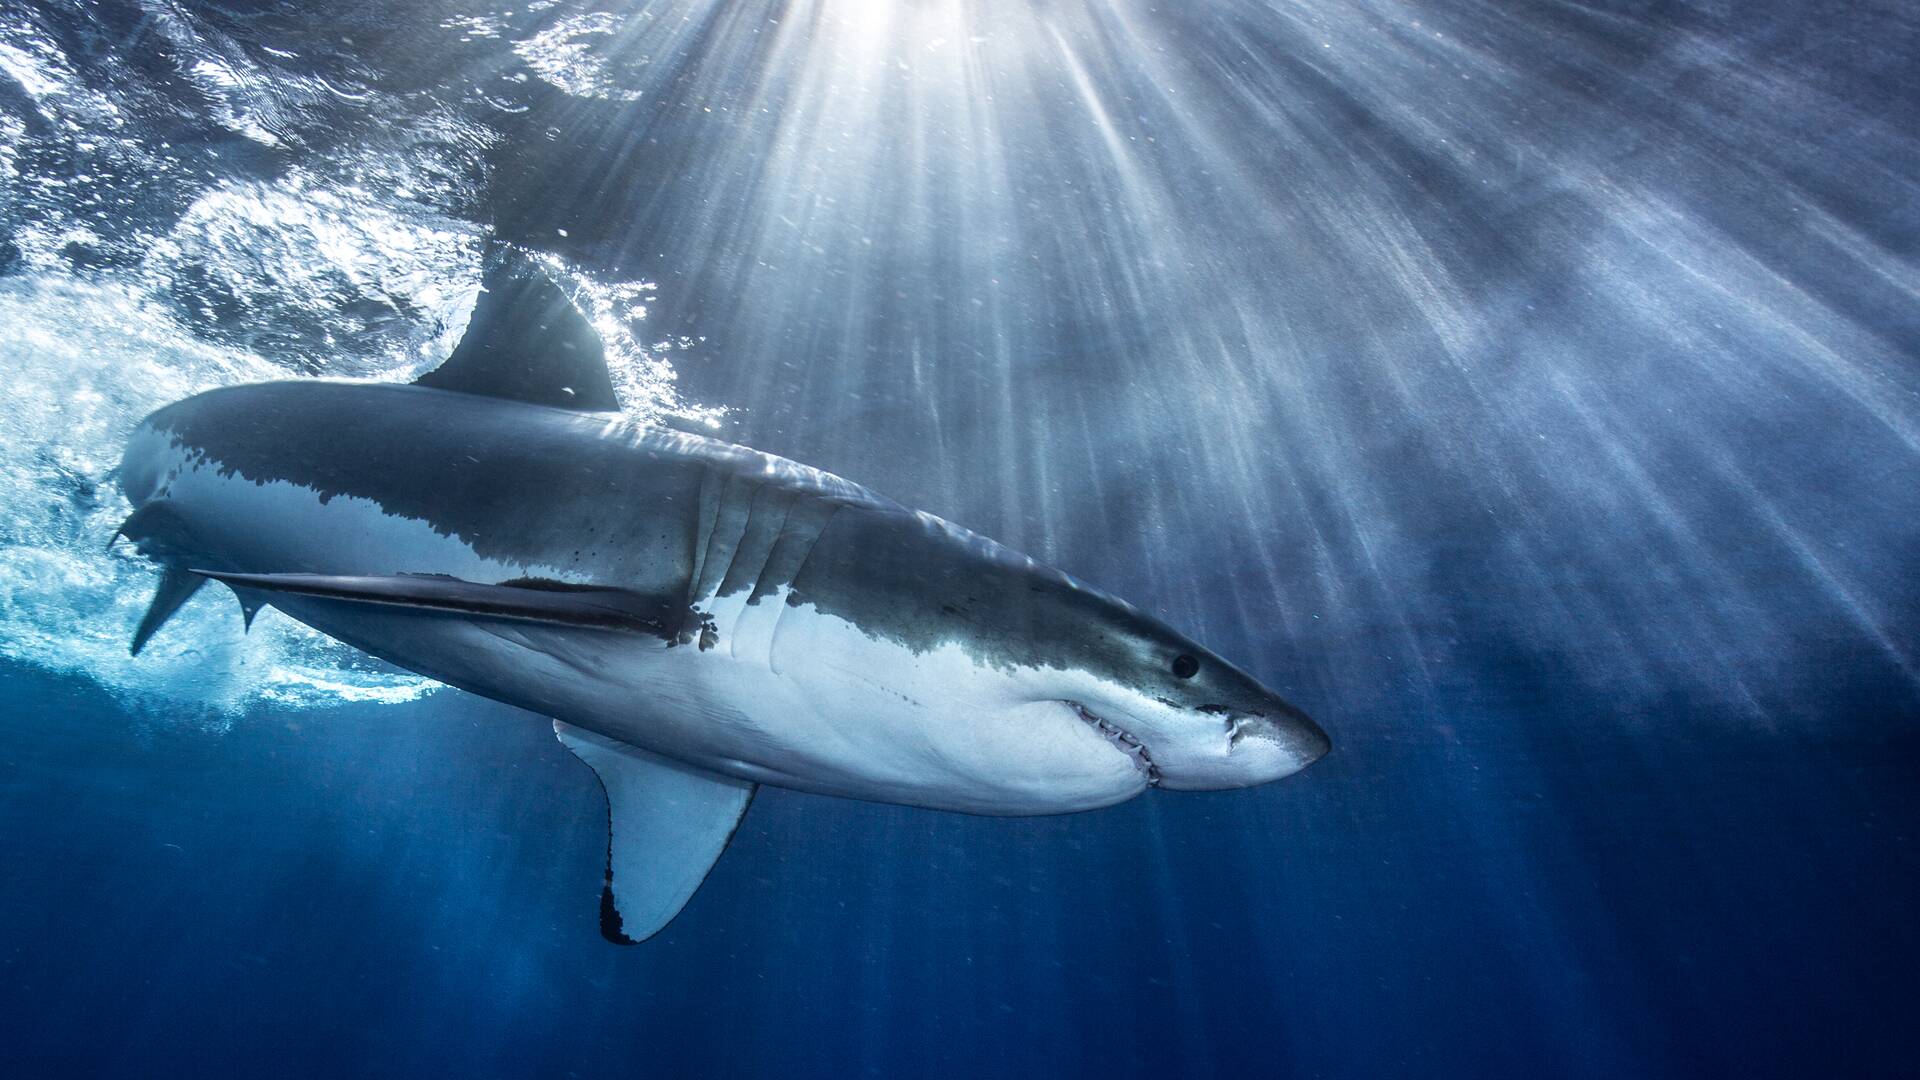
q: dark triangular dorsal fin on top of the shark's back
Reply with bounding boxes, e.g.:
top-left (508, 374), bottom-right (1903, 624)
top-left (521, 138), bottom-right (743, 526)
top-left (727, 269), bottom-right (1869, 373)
top-left (415, 244), bottom-right (620, 411)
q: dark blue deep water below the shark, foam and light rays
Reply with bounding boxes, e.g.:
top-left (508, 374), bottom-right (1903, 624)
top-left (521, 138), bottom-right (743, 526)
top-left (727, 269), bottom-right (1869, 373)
top-left (0, 657), bottom-right (1920, 1076)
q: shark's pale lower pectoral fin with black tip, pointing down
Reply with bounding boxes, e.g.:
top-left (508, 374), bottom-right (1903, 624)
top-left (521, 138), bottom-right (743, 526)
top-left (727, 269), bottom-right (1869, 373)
top-left (553, 721), bottom-right (755, 945)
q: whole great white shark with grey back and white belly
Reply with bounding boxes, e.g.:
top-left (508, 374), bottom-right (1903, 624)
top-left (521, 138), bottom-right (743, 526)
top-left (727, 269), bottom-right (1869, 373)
top-left (119, 254), bottom-right (1329, 942)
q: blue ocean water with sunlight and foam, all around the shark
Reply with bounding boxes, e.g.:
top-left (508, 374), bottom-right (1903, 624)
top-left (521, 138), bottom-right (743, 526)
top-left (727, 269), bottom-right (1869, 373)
top-left (0, 0), bottom-right (1920, 1078)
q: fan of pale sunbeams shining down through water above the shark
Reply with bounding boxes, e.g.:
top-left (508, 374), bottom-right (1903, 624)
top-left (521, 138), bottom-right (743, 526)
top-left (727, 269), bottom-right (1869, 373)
top-left (480, 0), bottom-right (1920, 715)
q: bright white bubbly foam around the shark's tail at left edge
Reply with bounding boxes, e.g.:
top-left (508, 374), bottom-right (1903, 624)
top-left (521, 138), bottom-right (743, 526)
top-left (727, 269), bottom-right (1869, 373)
top-left (0, 277), bottom-right (441, 723)
